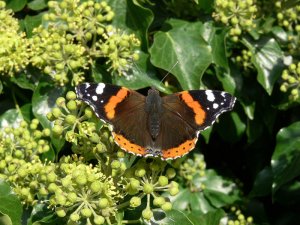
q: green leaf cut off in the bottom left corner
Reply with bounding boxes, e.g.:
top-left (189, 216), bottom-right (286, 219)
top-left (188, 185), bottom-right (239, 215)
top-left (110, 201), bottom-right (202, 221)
top-left (0, 179), bottom-right (22, 225)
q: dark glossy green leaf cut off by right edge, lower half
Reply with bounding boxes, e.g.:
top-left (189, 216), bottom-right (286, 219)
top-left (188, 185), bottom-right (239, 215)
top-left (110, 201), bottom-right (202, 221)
top-left (271, 122), bottom-right (300, 194)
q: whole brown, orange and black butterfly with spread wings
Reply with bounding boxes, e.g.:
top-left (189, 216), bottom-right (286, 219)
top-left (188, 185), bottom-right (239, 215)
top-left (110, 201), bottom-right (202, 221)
top-left (76, 83), bottom-right (236, 159)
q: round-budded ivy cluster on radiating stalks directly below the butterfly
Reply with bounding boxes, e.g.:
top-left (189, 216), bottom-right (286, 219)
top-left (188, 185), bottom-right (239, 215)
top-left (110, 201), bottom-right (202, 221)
top-left (122, 159), bottom-right (179, 220)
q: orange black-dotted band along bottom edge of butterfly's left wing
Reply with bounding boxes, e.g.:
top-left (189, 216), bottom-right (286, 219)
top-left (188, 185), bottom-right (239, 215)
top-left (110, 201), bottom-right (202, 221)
top-left (112, 132), bottom-right (146, 155)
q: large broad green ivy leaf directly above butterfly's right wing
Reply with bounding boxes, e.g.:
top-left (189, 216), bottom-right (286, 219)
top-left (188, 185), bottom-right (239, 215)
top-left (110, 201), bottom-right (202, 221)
top-left (150, 20), bottom-right (228, 90)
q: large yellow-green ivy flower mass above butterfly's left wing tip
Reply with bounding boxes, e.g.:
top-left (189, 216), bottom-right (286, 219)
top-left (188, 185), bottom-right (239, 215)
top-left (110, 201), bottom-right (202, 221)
top-left (31, 0), bottom-right (140, 86)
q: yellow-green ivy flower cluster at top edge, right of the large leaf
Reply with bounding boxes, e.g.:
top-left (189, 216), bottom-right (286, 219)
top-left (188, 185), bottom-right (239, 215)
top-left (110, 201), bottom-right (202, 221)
top-left (213, 0), bottom-right (257, 42)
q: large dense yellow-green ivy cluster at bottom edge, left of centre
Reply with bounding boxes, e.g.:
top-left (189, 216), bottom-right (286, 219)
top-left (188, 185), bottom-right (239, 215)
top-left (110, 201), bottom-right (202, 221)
top-left (48, 156), bottom-right (120, 224)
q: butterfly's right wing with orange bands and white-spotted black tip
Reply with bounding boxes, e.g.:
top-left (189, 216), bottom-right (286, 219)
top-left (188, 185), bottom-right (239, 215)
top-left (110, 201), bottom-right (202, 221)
top-left (156, 90), bottom-right (235, 159)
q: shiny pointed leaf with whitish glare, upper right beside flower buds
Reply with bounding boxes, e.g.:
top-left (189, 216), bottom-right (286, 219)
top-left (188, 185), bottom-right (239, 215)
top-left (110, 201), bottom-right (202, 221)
top-left (243, 37), bottom-right (284, 95)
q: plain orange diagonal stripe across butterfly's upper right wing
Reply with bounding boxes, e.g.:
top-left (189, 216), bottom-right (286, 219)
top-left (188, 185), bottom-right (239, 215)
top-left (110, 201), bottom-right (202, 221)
top-left (180, 91), bottom-right (206, 125)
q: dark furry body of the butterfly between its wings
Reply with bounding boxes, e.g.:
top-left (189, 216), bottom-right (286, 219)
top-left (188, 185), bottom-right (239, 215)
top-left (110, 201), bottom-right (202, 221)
top-left (145, 88), bottom-right (163, 140)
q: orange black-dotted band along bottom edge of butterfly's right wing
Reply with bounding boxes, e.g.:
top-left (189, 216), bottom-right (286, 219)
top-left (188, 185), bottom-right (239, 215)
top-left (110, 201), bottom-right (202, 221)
top-left (162, 138), bottom-right (197, 159)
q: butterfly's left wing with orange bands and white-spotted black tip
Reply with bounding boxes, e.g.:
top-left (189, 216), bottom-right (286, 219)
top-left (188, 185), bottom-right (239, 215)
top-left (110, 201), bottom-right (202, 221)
top-left (76, 83), bottom-right (150, 155)
